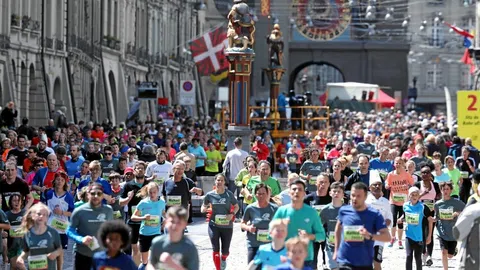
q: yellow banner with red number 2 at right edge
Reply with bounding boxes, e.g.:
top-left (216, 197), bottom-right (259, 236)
top-left (457, 91), bottom-right (480, 148)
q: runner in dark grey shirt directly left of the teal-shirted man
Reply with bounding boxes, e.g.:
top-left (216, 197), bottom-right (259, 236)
top-left (240, 184), bottom-right (278, 263)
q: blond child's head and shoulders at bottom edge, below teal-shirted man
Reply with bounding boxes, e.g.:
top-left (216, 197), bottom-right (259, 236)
top-left (275, 237), bottom-right (312, 270)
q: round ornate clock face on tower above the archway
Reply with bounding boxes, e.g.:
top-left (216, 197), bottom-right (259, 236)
top-left (292, 0), bottom-right (352, 41)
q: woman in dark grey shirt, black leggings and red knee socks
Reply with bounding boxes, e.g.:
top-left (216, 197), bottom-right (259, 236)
top-left (201, 174), bottom-right (239, 270)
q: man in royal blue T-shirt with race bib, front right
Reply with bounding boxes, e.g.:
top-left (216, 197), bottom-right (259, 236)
top-left (333, 182), bottom-right (391, 270)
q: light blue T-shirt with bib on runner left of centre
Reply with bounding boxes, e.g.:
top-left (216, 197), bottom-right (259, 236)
top-left (137, 198), bottom-right (165, 236)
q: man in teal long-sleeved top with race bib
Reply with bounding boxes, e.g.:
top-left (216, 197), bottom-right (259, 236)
top-left (273, 179), bottom-right (325, 269)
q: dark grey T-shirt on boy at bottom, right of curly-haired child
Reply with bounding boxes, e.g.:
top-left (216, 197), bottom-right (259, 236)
top-left (148, 234), bottom-right (200, 270)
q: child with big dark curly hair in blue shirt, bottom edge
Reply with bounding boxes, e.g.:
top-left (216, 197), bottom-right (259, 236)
top-left (92, 220), bottom-right (137, 270)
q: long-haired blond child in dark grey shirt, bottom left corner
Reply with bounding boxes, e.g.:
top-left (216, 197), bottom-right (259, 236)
top-left (17, 203), bottom-right (63, 270)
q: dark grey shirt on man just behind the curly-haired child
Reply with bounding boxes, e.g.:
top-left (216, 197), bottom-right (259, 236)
top-left (68, 203), bottom-right (113, 258)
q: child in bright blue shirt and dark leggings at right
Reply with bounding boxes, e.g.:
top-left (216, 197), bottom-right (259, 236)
top-left (398, 187), bottom-right (433, 270)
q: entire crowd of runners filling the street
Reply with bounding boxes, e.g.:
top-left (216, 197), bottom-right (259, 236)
top-left (0, 102), bottom-right (480, 270)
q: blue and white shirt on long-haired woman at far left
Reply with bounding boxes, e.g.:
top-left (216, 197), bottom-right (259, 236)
top-left (46, 189), bottom-right (75, 234)
